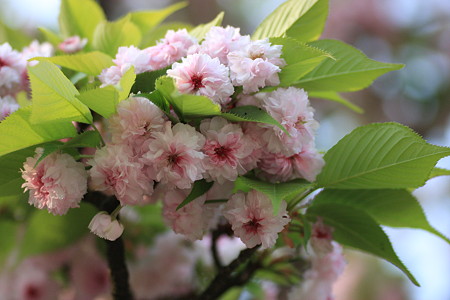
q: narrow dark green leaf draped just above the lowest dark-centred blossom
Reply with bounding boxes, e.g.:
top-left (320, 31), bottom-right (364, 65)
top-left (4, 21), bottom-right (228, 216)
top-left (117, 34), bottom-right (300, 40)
top-left (233, 176), bottom-right (312, 215)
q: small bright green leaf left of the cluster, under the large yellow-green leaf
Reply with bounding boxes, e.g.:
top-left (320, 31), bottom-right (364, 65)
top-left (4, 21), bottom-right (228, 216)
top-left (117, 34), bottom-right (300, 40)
top-left (77, 86), bottom-right (119, 118)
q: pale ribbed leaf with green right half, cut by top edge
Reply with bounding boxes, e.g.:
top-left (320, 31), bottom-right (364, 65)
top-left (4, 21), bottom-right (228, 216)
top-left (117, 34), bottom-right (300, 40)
top-left (252, 0), bottom-right (328, 41)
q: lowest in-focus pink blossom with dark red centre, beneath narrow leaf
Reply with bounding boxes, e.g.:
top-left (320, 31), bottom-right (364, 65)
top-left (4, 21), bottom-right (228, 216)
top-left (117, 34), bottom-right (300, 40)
top-left (223, 190), bottom-right (290, 249)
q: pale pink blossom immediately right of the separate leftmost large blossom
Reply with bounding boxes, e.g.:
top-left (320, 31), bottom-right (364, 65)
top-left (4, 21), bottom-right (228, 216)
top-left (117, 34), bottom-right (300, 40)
top-left (88, 144), bottom-right (153, 205)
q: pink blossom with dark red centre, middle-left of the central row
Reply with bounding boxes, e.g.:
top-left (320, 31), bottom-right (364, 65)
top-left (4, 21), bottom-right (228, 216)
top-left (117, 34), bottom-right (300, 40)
top-left (143, 122), bottom-right (205, 189)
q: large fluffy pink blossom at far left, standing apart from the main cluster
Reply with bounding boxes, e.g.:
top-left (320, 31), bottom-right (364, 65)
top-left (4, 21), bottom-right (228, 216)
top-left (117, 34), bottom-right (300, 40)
top-left (22, 148), bottom-right (87, 215)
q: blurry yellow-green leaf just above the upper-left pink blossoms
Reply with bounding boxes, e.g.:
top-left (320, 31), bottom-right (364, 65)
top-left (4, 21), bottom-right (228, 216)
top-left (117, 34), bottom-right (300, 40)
top-left (93, 17), bottom-right (142, 56)
